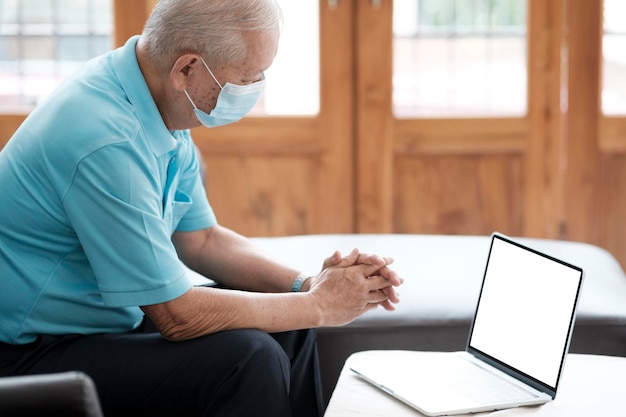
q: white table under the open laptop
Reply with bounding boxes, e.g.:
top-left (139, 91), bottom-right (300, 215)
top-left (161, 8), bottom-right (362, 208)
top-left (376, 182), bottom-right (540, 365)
top-left (324, 351), bottom-right (626, 417)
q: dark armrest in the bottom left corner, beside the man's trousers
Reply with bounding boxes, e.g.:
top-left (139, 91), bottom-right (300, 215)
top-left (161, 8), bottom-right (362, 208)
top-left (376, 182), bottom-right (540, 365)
top-left (0, 372), bottom-right (103, 417)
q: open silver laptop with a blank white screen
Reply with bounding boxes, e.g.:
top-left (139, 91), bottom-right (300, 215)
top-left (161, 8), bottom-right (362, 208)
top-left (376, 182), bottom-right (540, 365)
top-left (350, 233), bottom-right (584, 416)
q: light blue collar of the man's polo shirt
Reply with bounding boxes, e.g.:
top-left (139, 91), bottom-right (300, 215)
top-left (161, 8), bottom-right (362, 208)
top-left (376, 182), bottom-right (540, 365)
top-left (113, 35), bottom-right (178, 156)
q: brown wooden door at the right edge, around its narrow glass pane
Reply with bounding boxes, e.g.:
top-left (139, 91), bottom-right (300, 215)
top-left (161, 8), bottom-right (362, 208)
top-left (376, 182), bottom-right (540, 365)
top-left (563, 0), bottom-right (626, 267)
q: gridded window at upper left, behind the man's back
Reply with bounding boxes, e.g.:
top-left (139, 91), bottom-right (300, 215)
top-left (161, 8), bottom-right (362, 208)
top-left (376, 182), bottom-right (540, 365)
top-left (0, 0), bottom-right (113, 112)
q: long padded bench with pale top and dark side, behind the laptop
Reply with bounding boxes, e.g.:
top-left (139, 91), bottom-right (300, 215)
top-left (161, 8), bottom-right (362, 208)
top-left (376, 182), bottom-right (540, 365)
top-left (241, 234), bottom-right (626, 401)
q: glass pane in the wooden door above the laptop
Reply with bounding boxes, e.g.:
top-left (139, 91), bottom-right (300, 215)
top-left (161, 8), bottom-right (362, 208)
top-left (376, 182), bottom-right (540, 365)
top-left (393, 0), bottom-right (527, 118)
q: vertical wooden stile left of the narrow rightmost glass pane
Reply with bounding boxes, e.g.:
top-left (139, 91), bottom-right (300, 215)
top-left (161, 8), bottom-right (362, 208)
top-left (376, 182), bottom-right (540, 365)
top-left (562, 0), bottom-right (612, 245)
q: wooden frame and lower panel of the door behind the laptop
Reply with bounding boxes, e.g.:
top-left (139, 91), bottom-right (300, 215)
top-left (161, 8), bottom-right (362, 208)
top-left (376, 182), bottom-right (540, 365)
top-left (356, 0), bottom-right (562, 237)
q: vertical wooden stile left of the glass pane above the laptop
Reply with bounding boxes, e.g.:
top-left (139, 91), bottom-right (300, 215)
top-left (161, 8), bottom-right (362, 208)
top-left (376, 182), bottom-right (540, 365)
top-left (353, 0), bottom-right (394, 233)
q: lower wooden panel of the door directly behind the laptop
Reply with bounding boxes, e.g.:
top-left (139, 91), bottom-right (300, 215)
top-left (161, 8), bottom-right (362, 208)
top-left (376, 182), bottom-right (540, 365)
top-left (393, 153), bottom-right (523, 235)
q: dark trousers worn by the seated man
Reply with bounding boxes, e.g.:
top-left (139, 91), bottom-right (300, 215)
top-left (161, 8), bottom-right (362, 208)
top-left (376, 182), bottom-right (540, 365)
top-left (0, 325), bottom-right (323, 417)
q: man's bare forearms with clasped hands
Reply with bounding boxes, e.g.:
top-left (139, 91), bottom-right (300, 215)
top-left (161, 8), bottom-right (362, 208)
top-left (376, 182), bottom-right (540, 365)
top-left (142, 226), bottom-right (402, 340)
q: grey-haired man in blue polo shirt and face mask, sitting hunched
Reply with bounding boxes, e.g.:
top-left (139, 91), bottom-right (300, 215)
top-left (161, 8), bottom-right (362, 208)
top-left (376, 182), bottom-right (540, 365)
top-left (0, 0), bottom-right (402, 417)
